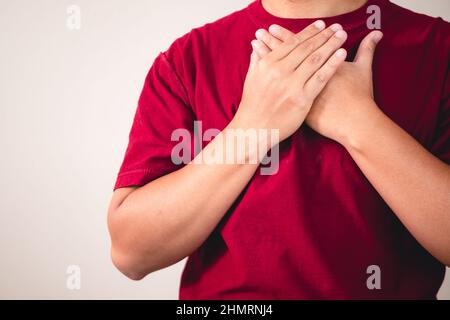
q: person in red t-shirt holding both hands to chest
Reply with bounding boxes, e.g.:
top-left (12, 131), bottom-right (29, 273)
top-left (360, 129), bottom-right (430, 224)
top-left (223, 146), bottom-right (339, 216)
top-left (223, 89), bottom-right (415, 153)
top-left (108, 0), bottom-right (450, 299)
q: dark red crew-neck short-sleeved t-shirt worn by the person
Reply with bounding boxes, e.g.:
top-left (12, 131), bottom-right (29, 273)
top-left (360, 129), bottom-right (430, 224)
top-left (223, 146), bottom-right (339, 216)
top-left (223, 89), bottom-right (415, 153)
top-left (115, 0), bottom-right (450, 299)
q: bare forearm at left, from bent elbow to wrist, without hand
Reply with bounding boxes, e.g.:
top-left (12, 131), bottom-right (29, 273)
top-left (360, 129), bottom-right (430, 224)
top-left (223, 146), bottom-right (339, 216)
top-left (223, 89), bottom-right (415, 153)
top-left (109, 118), bottom-right (259, 279)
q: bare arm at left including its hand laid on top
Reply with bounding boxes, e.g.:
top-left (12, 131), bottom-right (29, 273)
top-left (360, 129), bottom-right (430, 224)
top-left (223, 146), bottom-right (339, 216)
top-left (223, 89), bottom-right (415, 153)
top-left (108, 22), bottom-right (345, 279)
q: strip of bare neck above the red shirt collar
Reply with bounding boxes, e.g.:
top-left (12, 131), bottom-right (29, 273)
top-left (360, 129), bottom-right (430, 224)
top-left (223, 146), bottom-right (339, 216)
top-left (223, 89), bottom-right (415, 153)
top-left (262, 0), bottom-right (367, 19)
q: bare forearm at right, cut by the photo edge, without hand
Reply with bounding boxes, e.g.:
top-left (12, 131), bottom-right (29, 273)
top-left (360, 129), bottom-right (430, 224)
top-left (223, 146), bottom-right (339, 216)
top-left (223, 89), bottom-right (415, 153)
top-left (343, 102), bottom-right (450, 265)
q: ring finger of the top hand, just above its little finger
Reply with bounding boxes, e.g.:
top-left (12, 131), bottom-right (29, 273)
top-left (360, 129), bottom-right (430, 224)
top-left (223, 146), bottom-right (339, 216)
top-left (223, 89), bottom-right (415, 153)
top-left (296, 30), bottom-right (347, 83)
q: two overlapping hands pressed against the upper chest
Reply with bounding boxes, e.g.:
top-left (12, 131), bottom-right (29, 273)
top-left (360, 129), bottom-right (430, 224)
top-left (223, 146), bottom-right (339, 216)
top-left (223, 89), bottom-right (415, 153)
top-left (235, 20), bottom-right (383, 148)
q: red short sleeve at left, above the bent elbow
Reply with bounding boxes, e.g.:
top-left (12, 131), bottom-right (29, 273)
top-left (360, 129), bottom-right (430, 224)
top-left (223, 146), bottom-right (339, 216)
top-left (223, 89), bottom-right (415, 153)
top-left (114, 53), bottom-right (194, 190)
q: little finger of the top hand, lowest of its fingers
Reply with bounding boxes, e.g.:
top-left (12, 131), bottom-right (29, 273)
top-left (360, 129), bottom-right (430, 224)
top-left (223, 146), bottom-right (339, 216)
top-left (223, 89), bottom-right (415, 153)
top-left (304, 48), bottom-right (347, 99)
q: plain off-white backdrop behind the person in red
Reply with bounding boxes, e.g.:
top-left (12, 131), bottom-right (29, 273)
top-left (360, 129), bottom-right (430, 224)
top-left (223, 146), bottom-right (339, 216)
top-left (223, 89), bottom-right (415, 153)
top-left (0, 0), bottom-right (450, 299)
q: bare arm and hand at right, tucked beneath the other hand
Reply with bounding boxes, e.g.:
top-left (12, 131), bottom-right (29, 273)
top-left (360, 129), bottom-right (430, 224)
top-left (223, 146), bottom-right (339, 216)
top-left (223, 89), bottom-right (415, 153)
top-left (255, 26), bottom-right (450, 266)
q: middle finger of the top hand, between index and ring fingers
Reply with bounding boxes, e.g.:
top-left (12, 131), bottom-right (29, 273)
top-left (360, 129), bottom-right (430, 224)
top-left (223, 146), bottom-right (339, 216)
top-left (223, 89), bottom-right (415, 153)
top-left (280, 24), bottom-right (342, 70)
